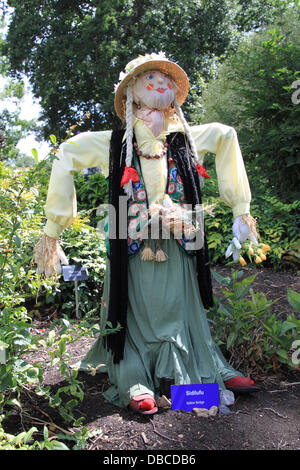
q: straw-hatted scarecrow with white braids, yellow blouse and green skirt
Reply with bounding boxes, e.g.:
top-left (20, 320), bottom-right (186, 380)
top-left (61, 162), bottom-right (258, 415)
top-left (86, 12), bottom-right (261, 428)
top-left (34, 53), bottom-right (258, 414)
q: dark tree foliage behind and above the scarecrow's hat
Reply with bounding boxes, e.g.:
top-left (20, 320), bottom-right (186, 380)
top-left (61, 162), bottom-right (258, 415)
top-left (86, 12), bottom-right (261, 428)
top-left (5, 0), bottom-right (288, 136)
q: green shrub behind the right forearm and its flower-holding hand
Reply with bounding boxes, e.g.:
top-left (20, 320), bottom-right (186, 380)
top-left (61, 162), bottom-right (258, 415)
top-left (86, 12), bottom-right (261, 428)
top-left (203, 164), bottom-right (300, 270)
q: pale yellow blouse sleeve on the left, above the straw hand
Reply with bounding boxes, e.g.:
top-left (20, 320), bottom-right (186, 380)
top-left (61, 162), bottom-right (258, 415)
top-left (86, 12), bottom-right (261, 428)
top-left (44, 131), bottom-right (111, 238)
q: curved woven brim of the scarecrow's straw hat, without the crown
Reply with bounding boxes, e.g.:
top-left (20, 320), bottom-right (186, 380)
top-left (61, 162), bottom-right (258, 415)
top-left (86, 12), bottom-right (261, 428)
top-left (115, 59), bottom-right (189, 121)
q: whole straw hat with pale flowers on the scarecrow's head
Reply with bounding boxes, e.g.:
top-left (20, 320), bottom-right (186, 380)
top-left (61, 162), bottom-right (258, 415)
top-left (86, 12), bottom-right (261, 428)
top-left (115, 52), bottom-right (189, 120)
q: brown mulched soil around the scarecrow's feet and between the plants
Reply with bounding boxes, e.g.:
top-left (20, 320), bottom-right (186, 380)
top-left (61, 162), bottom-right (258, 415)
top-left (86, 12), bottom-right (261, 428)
top-left (5, 266), bottom-right (300, 453)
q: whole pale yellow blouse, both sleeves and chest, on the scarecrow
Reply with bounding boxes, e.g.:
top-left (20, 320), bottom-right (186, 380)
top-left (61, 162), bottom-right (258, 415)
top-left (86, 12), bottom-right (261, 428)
top-left (45, 118), bottom-right (251, 238)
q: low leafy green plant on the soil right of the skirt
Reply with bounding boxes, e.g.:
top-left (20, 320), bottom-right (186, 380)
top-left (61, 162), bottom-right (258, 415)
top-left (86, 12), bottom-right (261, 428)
top-left (209, 271), bottom-right (300, 371)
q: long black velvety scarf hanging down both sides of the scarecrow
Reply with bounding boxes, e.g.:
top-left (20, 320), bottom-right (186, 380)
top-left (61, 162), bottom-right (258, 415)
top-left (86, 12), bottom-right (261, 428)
top-left (104, 130), bottom-right (213, 364)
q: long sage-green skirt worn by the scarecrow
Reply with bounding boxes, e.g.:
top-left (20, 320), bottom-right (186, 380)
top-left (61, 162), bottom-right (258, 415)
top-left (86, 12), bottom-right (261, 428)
top-left (80, 239), bottom-right (242, 407)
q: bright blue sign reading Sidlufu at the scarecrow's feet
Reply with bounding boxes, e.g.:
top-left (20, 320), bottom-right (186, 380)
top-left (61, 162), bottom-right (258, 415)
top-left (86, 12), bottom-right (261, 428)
top-left (171, 383), bottom-right (220, 411)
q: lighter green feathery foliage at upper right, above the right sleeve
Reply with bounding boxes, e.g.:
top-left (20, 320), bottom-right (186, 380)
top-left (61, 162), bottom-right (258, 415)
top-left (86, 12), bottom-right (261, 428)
top-left (194, 10), bottom-right (300, 202)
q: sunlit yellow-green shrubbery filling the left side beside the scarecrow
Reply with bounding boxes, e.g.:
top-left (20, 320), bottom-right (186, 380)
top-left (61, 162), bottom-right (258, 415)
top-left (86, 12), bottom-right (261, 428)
top-left (0, 155), bottom-right (113, 450)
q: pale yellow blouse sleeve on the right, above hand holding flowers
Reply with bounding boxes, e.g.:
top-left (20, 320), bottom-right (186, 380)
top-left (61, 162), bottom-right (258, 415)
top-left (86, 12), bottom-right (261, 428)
top-left (191, 122), bottom-right (251, 217)
